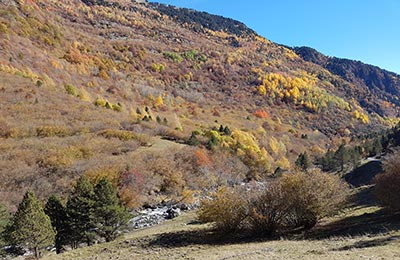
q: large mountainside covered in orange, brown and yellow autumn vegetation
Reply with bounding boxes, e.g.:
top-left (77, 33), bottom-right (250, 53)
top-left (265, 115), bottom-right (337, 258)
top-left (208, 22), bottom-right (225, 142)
top-left (0, 0), bottom-right (398, 207)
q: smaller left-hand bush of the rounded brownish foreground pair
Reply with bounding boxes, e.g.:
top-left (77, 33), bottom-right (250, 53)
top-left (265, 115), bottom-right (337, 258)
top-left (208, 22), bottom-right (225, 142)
top-left (197, 188), bottom-right (247, 232)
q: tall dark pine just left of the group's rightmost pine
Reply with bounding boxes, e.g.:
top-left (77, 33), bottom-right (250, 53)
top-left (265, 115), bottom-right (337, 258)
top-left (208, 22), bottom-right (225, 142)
top-left (66, 176), bottom-right (95, 248)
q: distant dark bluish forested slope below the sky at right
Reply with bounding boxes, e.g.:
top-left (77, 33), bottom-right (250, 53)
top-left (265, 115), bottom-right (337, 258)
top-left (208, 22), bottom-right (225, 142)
top-left (294, 47), bottom-right (400, 116)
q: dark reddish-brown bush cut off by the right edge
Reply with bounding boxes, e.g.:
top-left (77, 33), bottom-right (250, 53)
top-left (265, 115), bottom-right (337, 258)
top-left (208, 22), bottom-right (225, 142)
top-left (374, 152), bottom-right (400, 211)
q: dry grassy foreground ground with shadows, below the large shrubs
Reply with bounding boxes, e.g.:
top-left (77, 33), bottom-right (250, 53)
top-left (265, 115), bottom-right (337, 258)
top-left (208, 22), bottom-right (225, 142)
top-left (38, 198), bottom-right (400, 260)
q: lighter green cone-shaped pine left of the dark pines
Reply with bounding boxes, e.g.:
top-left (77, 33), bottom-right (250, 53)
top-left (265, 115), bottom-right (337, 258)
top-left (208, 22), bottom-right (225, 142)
top-left (9, 191), bottom-right (55, 258)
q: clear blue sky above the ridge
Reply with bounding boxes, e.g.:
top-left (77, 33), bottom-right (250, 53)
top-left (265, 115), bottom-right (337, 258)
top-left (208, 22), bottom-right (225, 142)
top-left (152, 0), bottom-right (400, 74)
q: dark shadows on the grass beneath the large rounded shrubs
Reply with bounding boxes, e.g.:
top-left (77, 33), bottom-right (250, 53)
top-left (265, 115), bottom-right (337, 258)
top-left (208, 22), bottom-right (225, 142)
top-left (148, 210), bottom-right (400, 250)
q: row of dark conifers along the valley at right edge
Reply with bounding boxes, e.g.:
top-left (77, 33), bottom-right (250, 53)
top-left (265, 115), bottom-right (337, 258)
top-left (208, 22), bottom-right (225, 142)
top-left (316, 123), bottom-right (400, 171)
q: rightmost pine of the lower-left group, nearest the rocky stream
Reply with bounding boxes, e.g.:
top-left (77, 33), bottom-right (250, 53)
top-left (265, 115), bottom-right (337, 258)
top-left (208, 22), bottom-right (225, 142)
top-left (94, 178), bottom-right (129, 242)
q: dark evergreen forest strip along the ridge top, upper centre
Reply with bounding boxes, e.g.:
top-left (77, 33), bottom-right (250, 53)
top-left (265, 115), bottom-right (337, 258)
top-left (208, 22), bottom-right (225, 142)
top-left (149, 3), bottom-right (256, 36)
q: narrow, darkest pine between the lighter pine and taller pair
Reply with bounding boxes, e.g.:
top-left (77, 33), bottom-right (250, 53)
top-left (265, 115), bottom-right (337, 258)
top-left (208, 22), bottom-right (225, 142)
top-left (44, 195), bottom-right (69, 254)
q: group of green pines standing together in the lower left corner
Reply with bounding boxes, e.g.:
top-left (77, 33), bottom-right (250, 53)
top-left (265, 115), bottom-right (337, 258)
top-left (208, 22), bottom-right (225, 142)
top-left (0, 177), bottom-right (130, 257)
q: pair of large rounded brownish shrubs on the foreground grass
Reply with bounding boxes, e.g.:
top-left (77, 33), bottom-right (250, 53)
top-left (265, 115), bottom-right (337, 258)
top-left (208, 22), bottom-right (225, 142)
top-left (198, 170), bottom-right (349, 235)
